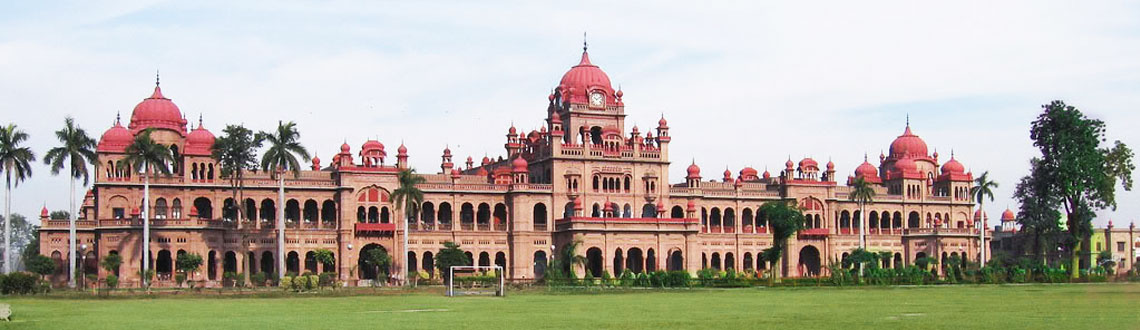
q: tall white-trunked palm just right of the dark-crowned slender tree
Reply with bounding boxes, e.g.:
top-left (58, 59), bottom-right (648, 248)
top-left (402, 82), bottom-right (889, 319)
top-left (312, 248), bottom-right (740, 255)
top-left (257, 121), bottom-right (309, 277)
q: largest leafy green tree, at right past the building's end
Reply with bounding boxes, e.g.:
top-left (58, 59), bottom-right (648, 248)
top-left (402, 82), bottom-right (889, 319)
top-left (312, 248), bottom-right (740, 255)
top-left (1029, 100), bottom-right (1135, 279)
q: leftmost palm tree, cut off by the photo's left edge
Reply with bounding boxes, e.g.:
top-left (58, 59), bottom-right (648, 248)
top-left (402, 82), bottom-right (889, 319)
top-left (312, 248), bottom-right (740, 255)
top-left (0, 123), bottom-right (35, 274)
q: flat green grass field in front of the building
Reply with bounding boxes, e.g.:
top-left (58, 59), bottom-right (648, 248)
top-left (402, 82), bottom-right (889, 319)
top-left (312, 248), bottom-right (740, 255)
top-left (0, 283), bottom-right (1140, 330)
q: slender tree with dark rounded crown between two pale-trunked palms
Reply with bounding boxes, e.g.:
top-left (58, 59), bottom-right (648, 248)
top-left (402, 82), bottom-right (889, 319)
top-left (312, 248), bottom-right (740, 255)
top-left (211, 124), bottom-right (261, 283)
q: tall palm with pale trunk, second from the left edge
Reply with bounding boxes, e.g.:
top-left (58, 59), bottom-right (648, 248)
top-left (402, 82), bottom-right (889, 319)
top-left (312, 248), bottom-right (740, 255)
top-left (43, 116), bottom-right (99, 288)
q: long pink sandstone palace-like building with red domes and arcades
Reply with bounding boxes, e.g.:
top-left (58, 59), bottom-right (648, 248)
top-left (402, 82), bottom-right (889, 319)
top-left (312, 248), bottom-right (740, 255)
top-left (40, 47), bottom-right (987, 285)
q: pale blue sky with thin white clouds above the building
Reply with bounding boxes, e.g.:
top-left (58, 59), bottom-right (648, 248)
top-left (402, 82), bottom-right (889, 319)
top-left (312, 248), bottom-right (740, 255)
top-left (0, 1), bottom-right (1140, 226)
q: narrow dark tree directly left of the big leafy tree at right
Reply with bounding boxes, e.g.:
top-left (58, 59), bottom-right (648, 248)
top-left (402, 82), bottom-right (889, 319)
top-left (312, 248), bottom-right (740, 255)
top-left (1013, 158), bottom-right (1061, 264)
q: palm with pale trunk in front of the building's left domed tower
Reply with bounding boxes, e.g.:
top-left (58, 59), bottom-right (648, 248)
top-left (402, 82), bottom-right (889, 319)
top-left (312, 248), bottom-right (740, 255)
top-left (115, 128), bottom-right (174, 288)
